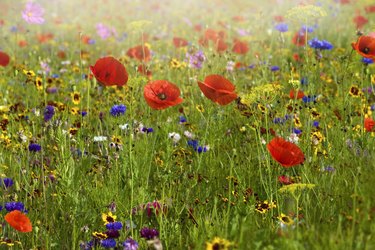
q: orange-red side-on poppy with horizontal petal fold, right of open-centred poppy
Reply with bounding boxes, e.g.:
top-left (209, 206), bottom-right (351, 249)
top-left (198, 75), bottom-right (237, 105)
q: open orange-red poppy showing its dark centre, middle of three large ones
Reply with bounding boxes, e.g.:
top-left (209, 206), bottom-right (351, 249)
top-left (143, 80), bottom-right (183, 110)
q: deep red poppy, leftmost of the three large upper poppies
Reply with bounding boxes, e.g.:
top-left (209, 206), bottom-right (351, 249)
top-left (90, 56), bottom-right (128, 86)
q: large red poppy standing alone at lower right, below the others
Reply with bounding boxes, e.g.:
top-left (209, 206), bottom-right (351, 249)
top-left (267, 137), bottom-right (305, 168)
